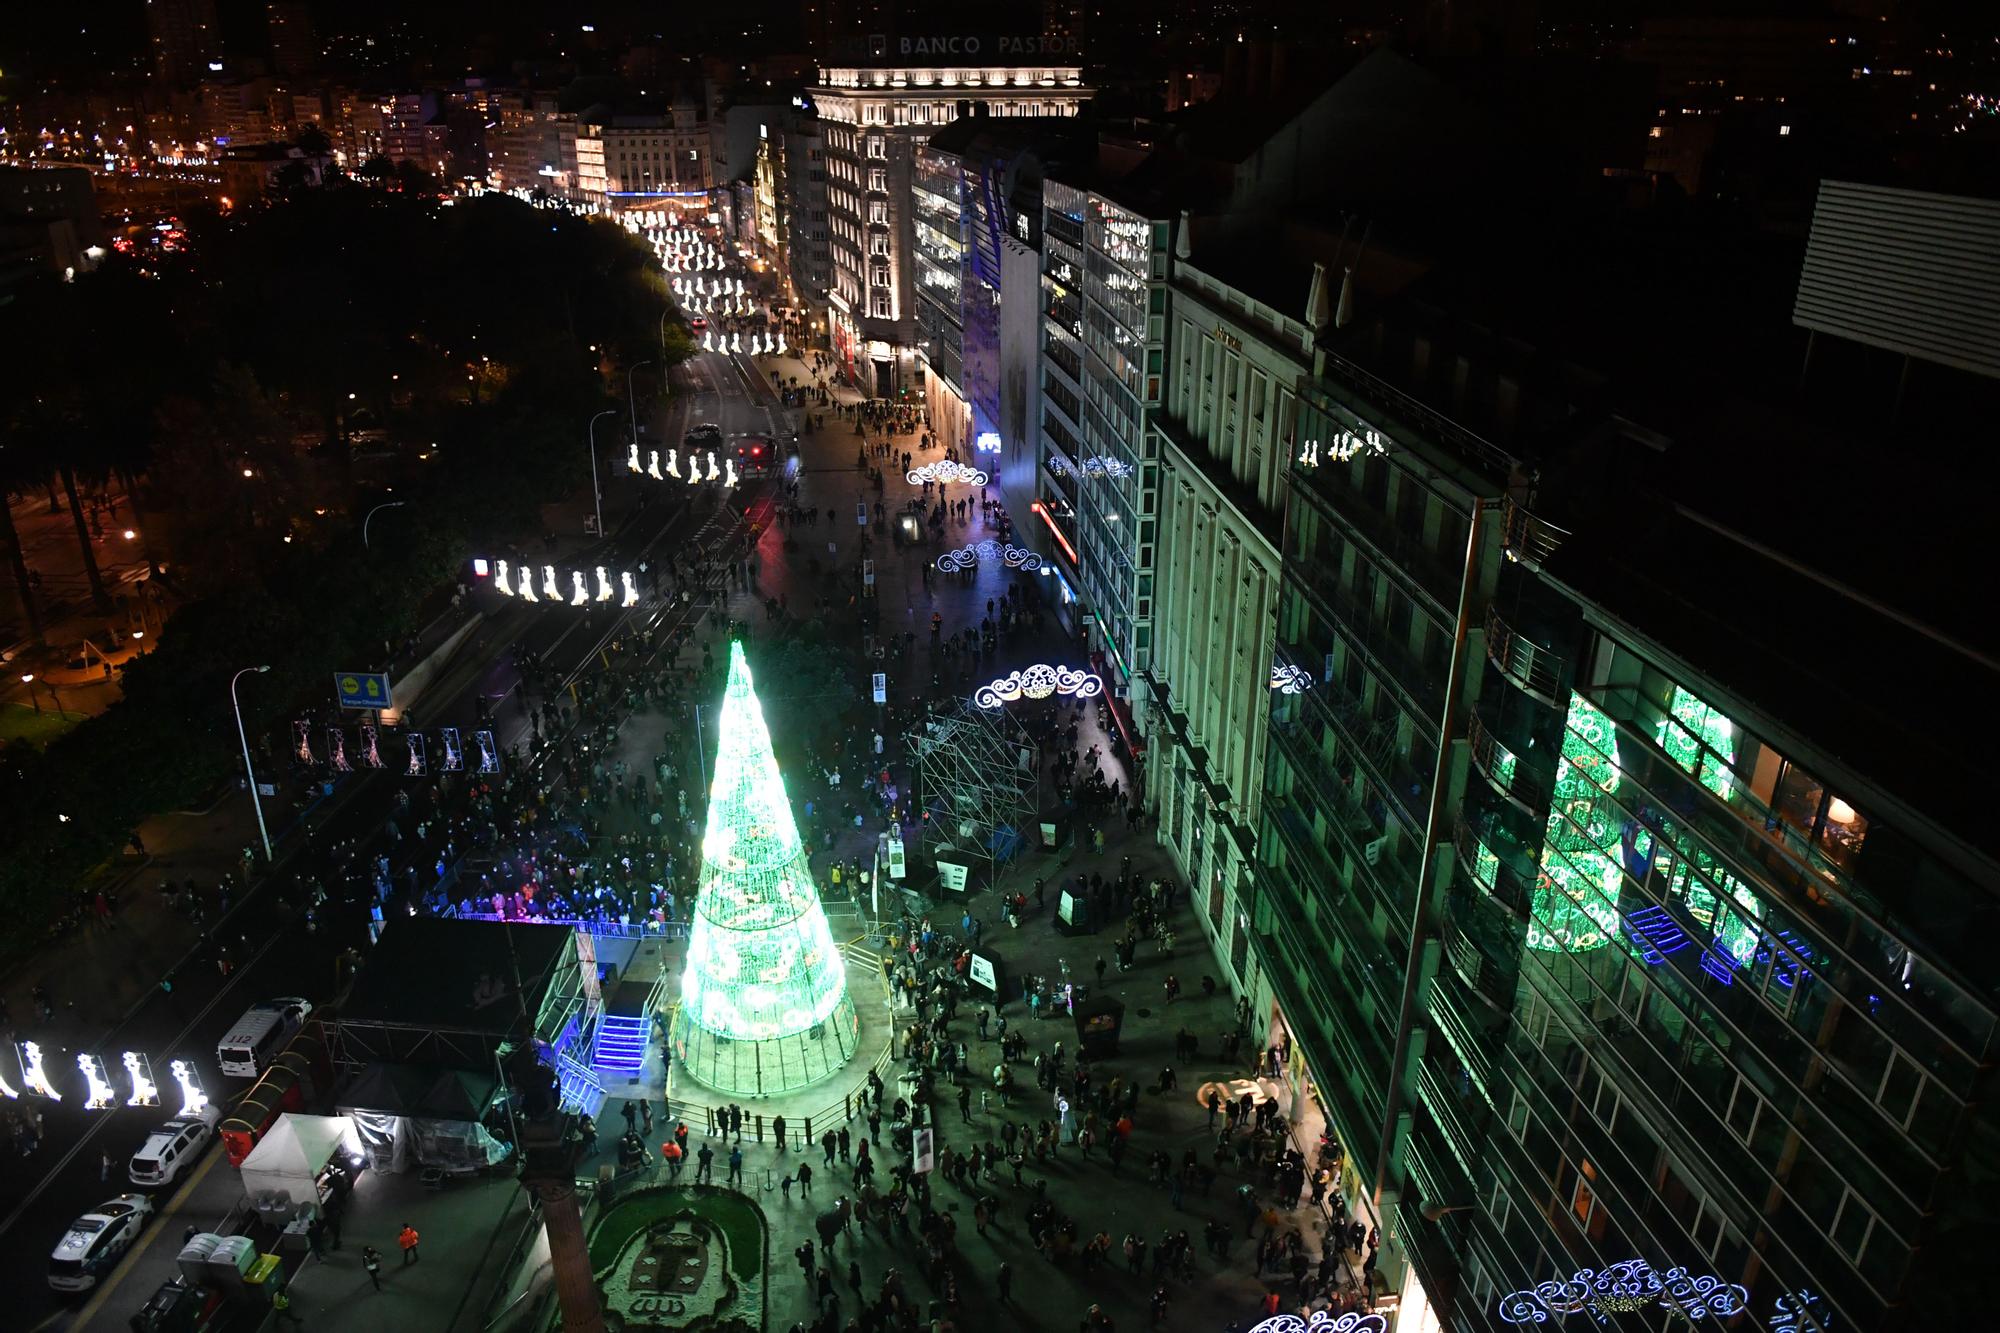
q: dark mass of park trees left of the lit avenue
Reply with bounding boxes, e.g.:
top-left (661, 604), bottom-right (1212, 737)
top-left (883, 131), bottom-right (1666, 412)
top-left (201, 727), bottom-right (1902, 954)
top-left (0, 187), bottom-right (688, 945)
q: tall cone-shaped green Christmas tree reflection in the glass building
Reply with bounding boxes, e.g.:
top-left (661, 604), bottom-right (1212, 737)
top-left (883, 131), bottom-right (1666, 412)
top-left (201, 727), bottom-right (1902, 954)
top-left (1528, 691), bottom-right (1622, 953)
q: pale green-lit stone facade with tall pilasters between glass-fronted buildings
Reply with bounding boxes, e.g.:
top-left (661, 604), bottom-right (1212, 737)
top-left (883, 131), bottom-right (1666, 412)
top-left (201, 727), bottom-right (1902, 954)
top-left (1142, 240), bottom-right (1324, 993)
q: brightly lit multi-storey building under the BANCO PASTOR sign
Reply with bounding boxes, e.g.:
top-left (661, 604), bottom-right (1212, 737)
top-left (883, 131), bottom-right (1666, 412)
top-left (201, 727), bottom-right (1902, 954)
top-left (812, 55), bottom-right (1092, 398)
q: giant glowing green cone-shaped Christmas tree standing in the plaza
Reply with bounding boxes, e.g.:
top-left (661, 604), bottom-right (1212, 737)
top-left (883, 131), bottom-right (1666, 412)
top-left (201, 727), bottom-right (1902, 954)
top-left (672, 642), bottom-right (860, 1097)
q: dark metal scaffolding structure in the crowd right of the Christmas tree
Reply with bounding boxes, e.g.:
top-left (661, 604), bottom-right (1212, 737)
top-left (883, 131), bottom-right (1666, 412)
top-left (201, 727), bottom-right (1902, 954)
top-left (910, 701), bottom-right (1040, 893)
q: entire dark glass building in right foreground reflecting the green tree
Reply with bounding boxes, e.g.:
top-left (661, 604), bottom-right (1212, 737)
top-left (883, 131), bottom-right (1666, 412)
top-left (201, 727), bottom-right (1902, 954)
top-left (1248, 316), bottom-right (2000, 1333)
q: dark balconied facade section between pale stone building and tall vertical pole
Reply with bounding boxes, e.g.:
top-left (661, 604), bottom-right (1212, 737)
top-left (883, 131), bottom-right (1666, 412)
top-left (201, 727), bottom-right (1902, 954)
top-left (1254, 380), bottom-right (1504, 1291)
